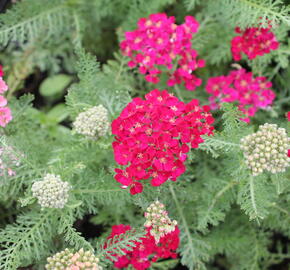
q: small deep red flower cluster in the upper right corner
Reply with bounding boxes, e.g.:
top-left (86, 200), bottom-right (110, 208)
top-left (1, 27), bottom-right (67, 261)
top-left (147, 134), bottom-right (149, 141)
top-left (231, 25), bottom-right (279, 61)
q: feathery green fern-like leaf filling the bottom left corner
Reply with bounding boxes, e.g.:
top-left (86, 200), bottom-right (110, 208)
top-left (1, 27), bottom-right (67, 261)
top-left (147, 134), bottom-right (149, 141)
top-left (0, 210), bottom-right (58, 270)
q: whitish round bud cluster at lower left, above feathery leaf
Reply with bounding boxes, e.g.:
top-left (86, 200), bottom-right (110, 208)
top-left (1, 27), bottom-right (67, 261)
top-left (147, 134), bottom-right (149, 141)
top-left (31, 173), bottom-right (71, 208)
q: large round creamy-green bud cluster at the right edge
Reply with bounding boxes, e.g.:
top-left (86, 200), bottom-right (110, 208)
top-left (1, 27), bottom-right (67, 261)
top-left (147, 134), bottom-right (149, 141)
top-left (241, 123), bottom-right (290, 176)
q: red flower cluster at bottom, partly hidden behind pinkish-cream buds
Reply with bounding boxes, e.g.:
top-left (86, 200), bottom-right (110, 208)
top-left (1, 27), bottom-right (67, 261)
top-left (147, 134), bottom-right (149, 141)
top-left (107, 224), bottom-right (179, 270)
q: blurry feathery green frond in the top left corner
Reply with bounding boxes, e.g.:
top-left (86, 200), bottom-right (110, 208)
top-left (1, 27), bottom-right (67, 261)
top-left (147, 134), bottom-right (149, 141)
top-left (0, 0), bottom-right (72, 47)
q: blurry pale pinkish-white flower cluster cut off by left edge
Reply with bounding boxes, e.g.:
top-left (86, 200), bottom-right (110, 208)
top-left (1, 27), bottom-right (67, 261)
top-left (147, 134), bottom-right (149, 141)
top-left (0, 145), bottom-right (24, 177)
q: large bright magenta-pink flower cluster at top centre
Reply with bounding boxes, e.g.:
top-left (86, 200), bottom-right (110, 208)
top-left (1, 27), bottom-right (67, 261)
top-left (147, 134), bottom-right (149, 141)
top-left (120, 13), bottom-right (205, 90)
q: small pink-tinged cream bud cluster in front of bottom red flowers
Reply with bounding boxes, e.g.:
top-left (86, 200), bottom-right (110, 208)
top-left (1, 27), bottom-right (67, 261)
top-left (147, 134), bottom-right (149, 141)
top-left (144, 201), bottom-right (177, 243)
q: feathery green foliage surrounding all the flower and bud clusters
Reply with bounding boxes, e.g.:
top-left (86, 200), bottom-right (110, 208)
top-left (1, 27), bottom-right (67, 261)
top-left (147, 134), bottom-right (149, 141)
top-left (0, 0), bottom-right (290, 270)
